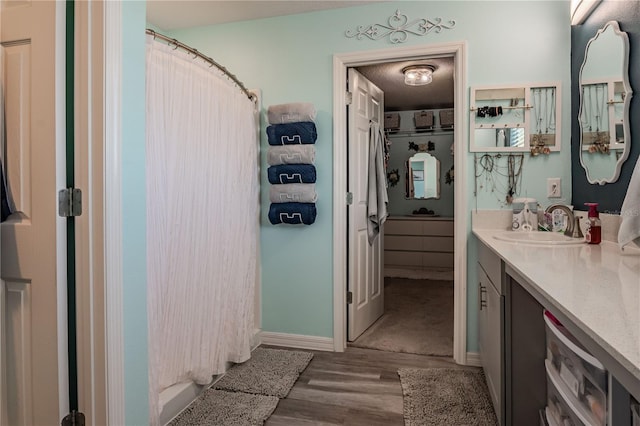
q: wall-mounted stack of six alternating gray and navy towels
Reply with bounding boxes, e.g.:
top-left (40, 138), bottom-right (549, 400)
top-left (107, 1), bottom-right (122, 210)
top-left (267, 102), bottom-right (318, 225)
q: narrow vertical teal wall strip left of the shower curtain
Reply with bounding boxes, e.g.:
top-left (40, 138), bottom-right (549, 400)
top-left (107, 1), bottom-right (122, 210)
top-left (121, 1), bottom-right (149, 425)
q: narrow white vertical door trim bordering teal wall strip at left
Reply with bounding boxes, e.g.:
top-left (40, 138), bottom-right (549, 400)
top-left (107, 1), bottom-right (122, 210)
top-left (102, 1), bottom-right (125, 425)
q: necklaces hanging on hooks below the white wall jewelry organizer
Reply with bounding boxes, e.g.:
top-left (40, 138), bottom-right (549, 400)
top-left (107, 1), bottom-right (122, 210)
top-left (474, 154), bottom-right (524, 206)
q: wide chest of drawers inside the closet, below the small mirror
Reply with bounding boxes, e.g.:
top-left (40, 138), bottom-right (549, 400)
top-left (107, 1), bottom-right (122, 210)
top-left (384, 216), bottom-right (453, 270)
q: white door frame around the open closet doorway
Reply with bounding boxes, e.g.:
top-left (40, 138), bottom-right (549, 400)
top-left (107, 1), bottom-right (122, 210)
top-left (333, 41), bottom-right (468, 364)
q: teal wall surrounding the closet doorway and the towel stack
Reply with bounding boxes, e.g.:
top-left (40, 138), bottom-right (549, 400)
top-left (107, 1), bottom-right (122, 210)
top-left (162, 1), bottom-right (571, 352)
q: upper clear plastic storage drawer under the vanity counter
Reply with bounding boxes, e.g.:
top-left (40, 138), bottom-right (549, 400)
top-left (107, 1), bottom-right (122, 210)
top-left (544, 311), bottom-right (607, 426)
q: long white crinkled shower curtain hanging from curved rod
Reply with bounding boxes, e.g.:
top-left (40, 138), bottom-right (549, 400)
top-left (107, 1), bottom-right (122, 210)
top-left (146, 36), bottom-right (259, 424)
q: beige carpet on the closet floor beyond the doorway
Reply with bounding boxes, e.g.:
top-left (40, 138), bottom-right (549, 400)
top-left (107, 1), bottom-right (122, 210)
top-left (350, 278), bottom-right (453, 356)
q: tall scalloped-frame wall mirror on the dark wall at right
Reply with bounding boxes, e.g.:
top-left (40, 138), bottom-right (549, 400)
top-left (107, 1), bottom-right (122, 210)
top-left (579, 21), bottom-right (632, 185)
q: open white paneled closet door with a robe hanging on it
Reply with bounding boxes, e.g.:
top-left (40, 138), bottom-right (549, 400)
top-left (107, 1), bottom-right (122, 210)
top-left (347, 68), bottom-right (384, 341)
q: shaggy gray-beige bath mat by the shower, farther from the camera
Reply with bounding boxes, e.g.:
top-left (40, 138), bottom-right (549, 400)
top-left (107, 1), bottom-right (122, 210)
top-left (213, 348), bottom-right (313, 398)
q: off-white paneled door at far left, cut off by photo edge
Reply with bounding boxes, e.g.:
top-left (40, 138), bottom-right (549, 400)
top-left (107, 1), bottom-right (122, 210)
top-left (0, 0), bottom-right (66, 425)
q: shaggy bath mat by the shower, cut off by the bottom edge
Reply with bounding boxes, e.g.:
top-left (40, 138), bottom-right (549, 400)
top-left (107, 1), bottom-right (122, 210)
top-left (169, 389), bottom-right (279, 426)
